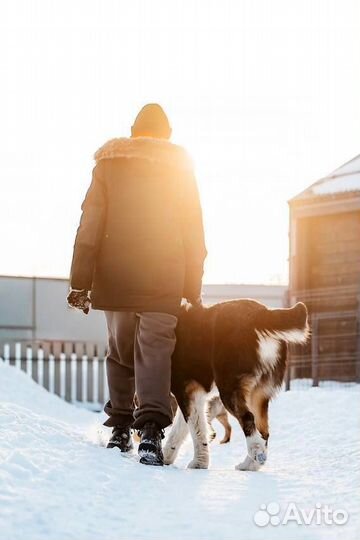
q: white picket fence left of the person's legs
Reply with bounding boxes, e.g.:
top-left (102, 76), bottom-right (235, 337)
top-left (0, 342), bottom-right (108, 411)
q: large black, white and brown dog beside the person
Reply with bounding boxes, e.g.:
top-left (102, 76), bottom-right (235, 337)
top-left (164, 299), bottom-right (309, 471)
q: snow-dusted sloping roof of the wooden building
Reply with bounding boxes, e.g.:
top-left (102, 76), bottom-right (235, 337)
top-left (291, 154), bottom-right (360, 201)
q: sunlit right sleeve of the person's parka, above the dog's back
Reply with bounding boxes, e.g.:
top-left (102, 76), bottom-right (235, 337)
top-left (181, 172), bottom-right (207, 299)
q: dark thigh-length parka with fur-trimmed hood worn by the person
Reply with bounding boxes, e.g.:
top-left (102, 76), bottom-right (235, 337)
top-left (70, 137), bottom-right (207, 315)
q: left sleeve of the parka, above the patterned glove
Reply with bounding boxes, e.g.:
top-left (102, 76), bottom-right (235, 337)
top-left (70, 165), bottom-right (106, 291)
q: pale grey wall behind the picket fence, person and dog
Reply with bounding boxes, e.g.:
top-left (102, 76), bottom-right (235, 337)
top-left (0, 276), bottom-right (286, 345)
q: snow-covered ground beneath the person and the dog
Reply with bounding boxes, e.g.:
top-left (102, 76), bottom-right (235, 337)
top-left (0, 362), bottom-right (360, 540)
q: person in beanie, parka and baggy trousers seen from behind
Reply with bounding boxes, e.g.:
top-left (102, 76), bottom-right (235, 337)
top-left (67, 103), bottom-right (207, 465)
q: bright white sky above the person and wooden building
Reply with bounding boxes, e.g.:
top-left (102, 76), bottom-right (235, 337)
top-left (0, 0), bottom-right (360, 283)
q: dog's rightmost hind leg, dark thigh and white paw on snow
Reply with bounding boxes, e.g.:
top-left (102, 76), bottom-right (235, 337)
top-left (220, 384), bottom-right (266, 471)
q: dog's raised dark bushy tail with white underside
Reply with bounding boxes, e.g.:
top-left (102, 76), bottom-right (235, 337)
top-left (262, 302), bottom-right (310, 343)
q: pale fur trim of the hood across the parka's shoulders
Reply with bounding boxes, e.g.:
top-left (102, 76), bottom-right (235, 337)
top-left (94, 137), bottom-right (193, 170)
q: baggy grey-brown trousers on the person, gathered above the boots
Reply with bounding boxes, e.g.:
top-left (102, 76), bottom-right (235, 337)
top-left (104, 311), bottom-right (177, 428)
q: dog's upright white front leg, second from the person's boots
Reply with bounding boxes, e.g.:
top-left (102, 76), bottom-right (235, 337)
top-left (188, 389), bottom-right (209, 469)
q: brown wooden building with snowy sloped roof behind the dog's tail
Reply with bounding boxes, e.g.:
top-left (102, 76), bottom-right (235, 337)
top-left (289, 155), bottom-right (360, 385)
